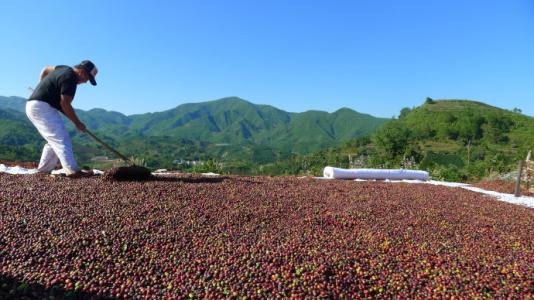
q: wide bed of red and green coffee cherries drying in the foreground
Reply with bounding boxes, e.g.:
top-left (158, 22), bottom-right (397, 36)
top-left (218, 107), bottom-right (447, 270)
top-left (0, 174), bottom-right (534, 299)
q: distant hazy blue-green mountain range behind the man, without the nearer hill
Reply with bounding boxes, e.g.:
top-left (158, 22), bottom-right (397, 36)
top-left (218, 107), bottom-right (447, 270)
top-left (0, 96), bottom-right (387, 162)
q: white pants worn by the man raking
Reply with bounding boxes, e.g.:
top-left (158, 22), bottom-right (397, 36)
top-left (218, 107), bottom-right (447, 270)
top-left (26, 100), bottom-right (80, 175)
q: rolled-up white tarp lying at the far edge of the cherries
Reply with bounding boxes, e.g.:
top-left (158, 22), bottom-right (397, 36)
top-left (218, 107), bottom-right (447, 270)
top-left (323, 167), bottom-right (429, 180)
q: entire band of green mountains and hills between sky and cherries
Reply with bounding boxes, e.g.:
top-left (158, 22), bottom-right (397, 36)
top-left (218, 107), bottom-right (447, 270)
top-left (0, 97), bottom-right (534, 181)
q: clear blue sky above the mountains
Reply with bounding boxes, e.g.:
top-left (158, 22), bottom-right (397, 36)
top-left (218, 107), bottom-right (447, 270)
top-left (0, 0), bottom-right (534, 117)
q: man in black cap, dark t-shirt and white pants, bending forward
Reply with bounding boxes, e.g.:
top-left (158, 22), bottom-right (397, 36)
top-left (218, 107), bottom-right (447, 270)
top-left (26, 60), bottom-right (98, 177)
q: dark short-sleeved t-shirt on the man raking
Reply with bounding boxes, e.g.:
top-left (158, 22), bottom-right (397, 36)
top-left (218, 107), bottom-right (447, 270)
top-left (28, 66), bottom-right (78, 112)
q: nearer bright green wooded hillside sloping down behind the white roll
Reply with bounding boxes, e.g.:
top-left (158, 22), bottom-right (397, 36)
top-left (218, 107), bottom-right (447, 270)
top-left (272, 99), bottom-right (534, 181)
